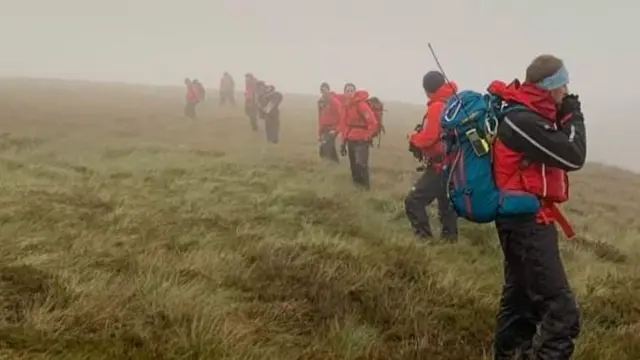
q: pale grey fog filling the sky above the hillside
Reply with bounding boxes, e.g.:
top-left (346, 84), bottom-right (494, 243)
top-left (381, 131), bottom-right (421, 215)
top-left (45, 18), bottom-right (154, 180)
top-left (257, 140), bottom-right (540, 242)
top-left (0, 0), bottom-right (640, 170)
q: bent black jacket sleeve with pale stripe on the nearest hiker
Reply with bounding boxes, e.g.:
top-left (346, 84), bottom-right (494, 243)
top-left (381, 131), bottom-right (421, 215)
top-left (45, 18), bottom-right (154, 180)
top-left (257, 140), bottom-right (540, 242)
top-left (498, 111), bottom-right (587, 171)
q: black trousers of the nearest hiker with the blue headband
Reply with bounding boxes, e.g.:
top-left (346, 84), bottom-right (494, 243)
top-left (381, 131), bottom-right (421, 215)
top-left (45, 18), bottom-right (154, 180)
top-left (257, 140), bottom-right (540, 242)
top-left (494, 216), bottom-right (580, 360)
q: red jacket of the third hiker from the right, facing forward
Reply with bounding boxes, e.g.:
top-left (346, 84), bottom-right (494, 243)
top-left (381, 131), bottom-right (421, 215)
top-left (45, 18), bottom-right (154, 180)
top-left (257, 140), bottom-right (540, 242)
top-left (338, 90), bottom-right (378, 141)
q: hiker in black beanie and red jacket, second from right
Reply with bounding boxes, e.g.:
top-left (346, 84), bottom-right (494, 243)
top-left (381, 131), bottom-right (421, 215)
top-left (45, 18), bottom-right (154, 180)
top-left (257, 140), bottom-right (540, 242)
top-left (404, 71), bottom-right (458, 241)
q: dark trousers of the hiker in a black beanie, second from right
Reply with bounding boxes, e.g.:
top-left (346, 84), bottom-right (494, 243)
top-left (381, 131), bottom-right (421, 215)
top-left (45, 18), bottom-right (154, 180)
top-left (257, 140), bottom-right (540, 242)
top-left (404, 168), bottom-right (458, 240)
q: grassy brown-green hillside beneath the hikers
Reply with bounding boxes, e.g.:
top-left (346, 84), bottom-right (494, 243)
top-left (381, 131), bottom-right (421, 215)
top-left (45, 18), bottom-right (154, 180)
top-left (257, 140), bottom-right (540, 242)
top-left (0, 80), bottom-right (640, 360)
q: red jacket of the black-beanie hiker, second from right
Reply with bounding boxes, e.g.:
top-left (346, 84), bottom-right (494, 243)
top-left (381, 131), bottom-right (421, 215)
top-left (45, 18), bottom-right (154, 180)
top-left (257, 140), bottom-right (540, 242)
top-left (409, 82), bottom-right (458, 166)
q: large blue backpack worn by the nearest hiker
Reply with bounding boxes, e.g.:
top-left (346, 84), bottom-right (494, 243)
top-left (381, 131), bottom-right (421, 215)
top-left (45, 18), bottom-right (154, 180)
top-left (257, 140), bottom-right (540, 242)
top-left (440, 90), bottom-right (540, 223)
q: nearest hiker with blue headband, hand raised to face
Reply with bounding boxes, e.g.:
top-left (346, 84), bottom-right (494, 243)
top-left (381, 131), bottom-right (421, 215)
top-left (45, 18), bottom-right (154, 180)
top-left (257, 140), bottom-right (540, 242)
top-left (488, 55), bottom-right (586, 360)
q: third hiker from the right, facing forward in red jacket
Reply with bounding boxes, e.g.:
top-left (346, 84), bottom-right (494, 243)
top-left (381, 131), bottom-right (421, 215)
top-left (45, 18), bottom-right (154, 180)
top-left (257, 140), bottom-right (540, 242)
top-left (338, 83), bottom-right (378, 190)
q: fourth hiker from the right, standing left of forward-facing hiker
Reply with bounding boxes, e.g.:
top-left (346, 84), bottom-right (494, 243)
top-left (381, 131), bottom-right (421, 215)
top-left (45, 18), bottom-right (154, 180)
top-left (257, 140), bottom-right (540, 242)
top-left (318, 82), bottom-right (343, 162)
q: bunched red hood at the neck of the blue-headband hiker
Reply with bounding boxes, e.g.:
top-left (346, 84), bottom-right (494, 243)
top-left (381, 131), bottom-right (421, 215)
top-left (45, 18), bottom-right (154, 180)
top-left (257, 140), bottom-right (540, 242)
top-left (487, 80), bottom-right (557, 121)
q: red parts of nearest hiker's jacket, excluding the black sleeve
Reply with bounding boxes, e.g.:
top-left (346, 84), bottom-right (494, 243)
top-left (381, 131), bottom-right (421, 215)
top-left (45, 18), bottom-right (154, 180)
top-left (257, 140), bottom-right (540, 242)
top-left (489, 81), bottom-right (573, 236)
